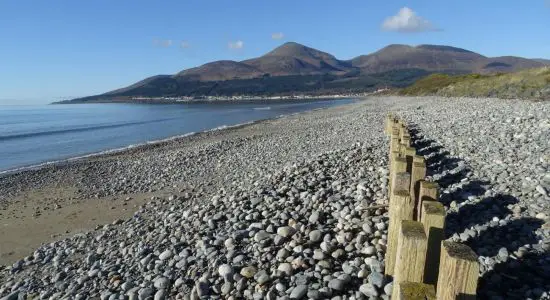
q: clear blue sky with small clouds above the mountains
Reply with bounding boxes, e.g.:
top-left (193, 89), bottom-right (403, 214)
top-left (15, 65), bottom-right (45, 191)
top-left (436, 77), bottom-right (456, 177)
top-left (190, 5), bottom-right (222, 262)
top-left (0, 0), bottom-right (550, 104)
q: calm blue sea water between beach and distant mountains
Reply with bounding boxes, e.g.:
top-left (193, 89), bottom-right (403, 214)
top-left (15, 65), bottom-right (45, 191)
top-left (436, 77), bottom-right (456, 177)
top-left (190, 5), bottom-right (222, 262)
top-left (0, 99), bottom-right (355, 173)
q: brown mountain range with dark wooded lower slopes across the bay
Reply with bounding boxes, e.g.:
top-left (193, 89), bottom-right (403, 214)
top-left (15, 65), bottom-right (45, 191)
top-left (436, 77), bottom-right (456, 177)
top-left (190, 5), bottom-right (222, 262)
top-left (64, 42), bottom-right (550, 102)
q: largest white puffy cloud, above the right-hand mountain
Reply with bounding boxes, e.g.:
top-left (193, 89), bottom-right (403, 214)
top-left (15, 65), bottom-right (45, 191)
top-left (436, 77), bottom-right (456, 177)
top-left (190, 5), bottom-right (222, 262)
top-left (382, 7), bottom-right (438, 32)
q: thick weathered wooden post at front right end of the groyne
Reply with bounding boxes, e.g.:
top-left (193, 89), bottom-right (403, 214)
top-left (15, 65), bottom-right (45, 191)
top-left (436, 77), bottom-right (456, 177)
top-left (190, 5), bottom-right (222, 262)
top-left (437, 241), bottom-right (479, 300)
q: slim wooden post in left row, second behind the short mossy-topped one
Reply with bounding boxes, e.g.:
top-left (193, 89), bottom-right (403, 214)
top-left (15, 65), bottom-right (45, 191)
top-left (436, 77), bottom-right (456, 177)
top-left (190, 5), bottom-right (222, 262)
top-left (385, 182), bottom-right (414, 275)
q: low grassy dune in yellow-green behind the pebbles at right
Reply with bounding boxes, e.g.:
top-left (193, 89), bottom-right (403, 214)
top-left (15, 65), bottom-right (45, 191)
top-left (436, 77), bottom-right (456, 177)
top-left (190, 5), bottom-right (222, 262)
top-left (398, 67), bottom-right (550, 100)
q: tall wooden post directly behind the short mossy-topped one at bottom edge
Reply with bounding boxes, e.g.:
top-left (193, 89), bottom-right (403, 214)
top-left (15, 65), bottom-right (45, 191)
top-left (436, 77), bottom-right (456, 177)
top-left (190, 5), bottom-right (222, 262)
top-left (392, 220), bottom-right (428, 299)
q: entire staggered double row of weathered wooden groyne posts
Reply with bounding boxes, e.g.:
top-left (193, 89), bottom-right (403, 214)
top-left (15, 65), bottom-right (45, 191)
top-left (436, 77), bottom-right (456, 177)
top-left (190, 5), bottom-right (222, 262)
top-left (385, 115), bottom-right (479, 300)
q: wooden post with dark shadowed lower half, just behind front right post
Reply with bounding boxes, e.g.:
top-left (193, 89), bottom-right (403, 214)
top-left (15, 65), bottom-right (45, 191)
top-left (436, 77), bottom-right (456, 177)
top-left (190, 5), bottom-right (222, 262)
top-left (422, 201), bottom-right (445, 285)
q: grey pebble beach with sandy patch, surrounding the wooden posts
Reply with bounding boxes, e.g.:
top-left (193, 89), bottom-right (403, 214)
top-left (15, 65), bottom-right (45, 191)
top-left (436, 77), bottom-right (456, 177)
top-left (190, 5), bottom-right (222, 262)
top-left (0, 97), bottom-right (550, 300)
